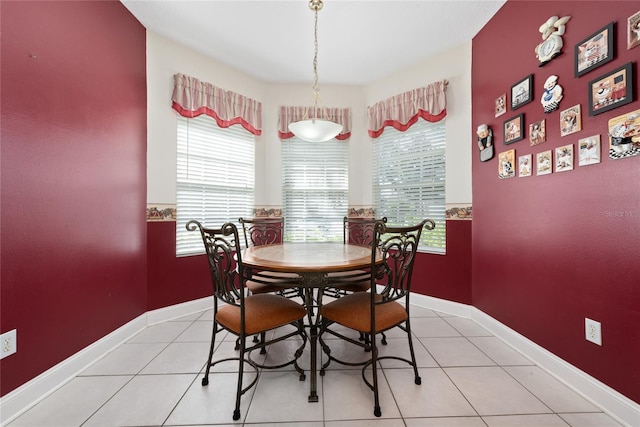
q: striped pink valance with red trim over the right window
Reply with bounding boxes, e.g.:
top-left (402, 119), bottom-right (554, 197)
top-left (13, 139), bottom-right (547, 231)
top-left (367, 80), bottom-right (449, 138)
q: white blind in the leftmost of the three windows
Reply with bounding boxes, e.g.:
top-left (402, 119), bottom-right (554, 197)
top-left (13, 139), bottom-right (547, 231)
top-left (176, 115), bottom-right (255, 255)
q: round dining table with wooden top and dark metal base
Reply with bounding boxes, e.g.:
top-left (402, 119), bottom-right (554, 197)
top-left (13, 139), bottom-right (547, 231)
top-left (241, 242), bottom-right (382, 402)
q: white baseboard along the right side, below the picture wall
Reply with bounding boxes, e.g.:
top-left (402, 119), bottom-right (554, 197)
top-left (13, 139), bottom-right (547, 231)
top-left (411, 294), bottom-right (640, 427)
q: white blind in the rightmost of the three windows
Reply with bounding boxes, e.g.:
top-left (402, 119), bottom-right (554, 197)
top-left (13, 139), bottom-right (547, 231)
top-left (373, 119), bottom-right (446, 253)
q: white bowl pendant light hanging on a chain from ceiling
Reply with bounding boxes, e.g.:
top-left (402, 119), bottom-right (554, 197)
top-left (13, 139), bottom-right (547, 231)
top-left (289, 0), bottom-right (342, 142)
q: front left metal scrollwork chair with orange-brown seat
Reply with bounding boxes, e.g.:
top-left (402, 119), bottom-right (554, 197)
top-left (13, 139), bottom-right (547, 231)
top-left (186, 220), bottom-right (307, 420)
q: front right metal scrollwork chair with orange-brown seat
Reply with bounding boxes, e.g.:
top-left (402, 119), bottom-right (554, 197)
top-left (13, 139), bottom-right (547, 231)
top-left (319, 220), bottom-right (435, 417)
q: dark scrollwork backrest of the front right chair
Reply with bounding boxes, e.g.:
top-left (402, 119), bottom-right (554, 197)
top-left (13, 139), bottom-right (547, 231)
top-left (371, 219), bottom-right (435, 303)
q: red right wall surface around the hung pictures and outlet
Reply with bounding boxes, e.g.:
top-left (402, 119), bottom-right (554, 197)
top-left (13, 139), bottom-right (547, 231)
top-left (470, 0), bottom-right (640, 402)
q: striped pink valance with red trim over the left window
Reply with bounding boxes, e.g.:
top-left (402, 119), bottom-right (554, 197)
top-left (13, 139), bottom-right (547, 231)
top-left (171, 74), bottom-right (262, 135)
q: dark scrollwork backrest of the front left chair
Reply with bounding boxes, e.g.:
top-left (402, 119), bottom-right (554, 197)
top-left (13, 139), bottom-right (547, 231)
top-left (187, 220), bottom-right (244, 308)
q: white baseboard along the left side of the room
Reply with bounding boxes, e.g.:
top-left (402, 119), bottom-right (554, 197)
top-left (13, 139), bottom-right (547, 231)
top-left (0, 297), bottom-right (211, 426)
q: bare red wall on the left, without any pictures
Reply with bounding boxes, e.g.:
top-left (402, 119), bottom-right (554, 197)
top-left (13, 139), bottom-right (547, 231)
top-left (0, 1), bottom-right (147, 395)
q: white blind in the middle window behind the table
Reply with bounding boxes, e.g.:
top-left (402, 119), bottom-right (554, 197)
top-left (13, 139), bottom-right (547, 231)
top-left (282, 137), bottom-right (349, 241)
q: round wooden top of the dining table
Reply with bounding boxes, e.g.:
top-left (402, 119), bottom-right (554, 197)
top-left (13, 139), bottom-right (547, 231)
top-left (242, 242), bottom-right (380, 273)
